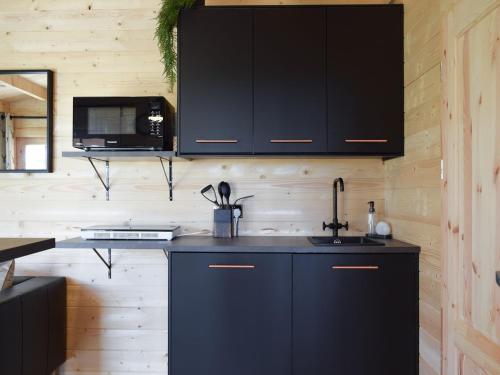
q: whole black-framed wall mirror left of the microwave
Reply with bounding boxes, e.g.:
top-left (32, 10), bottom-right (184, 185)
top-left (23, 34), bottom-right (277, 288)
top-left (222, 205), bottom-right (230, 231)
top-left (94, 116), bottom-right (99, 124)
top-left (0, 70), bottom-right (53, 173)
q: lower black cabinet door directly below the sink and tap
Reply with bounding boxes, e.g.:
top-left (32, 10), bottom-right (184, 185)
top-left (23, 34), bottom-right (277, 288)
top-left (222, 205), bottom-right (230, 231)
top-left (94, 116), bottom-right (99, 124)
top-left (293, 254), bottom-right (418, 375)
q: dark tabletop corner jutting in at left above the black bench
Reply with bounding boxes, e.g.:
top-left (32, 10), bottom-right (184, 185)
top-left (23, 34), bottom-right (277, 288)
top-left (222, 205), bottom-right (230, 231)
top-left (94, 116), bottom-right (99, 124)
top-left (0, 238), bottom-right (56, 262)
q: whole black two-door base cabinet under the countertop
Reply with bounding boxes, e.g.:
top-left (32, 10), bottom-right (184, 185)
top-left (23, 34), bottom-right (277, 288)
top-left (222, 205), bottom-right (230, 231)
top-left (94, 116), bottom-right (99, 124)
top-left (169, 253), bottom-right (418, 375)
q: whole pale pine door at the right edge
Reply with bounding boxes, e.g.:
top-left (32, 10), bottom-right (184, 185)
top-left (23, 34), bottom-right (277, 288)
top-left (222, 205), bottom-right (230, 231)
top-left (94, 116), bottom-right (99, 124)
top-left (442, 0), bottom-right (500, 375)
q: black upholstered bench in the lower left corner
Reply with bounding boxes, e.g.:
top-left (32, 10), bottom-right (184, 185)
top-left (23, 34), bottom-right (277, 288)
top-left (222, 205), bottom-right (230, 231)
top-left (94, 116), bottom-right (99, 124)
top-left (0, 277), bottom-right (66, 375)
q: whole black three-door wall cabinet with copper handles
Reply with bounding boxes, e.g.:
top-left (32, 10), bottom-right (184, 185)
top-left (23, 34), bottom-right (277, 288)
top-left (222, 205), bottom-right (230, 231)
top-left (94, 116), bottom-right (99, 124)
top-left (178, 5), bottom-right (404, 157)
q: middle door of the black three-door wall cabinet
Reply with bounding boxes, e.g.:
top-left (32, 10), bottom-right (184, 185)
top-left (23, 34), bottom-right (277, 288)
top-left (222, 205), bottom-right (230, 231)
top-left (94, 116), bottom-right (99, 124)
top-left (254, 7), bottom-right (326, 154)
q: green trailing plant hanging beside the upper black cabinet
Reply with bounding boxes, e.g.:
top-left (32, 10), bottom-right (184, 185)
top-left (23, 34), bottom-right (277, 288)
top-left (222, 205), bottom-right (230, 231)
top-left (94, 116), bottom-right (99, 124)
top-left (155, 0), bottom-right (196, 88)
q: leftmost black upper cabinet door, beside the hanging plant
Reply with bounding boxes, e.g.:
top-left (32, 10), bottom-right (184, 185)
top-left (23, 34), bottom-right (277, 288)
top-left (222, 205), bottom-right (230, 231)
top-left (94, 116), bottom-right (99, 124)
top-left (178, 7), bottom-right (253, 154)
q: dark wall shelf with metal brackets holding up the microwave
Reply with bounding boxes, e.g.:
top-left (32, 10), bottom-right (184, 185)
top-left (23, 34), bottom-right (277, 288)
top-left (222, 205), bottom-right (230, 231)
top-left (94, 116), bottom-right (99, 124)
top-left (62, 150), bottom-right (182, 201)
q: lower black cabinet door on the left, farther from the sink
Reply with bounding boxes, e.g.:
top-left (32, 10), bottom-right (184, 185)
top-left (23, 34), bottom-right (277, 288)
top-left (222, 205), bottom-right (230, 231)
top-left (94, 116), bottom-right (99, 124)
top-left (169, 253), bottom-right (292, 375)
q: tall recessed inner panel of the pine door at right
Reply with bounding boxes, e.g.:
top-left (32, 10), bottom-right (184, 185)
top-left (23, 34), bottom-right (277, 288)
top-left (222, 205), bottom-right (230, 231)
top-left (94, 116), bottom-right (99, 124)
top-left (459, 9), bottom-right (500, 341)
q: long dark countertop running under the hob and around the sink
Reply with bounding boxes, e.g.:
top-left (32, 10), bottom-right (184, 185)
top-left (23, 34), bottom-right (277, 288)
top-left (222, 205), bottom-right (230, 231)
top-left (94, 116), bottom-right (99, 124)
top-left (56, 236), bottom-right (420, 254)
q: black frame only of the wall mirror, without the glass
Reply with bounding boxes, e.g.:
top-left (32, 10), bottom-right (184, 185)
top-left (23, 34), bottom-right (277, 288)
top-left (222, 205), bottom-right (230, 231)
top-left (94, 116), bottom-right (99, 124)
top-left (0, 69), bottom-right (54, 173)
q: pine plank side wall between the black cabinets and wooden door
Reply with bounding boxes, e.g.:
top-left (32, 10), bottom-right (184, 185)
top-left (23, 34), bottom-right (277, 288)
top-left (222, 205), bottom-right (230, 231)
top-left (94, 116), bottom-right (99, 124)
top-left (385, 0), bottom-right (453, 375)
